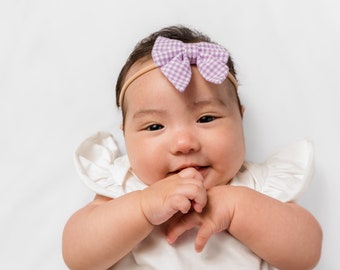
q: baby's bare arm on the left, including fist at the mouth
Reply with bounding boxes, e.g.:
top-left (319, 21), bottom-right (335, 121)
top-left (63, 169), bottom-right (207, 270)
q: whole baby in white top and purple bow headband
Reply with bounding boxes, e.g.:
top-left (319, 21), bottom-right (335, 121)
top-left (63, 26), bottom-right (322, 270)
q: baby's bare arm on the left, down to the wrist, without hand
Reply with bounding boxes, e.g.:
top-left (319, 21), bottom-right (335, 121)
top-left (63, 192), bottom-right (153, 270)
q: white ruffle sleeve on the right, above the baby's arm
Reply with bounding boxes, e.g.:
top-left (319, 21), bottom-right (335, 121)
top-left (236, 140), bottom-right (314, 202)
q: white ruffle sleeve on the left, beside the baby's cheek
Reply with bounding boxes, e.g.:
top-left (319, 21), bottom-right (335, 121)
top-left (75, 132), bottom-right (146, 198)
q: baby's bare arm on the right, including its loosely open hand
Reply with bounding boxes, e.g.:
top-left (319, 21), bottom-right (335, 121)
top-left (168, 185), bottom-right (322, 270)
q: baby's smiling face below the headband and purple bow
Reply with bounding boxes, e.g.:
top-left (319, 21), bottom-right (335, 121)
top-left (124, 60), bottom-right (245, 188)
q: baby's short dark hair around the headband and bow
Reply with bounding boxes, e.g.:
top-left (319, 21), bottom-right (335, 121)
top-left (116, 26), bottom-right (241, 109)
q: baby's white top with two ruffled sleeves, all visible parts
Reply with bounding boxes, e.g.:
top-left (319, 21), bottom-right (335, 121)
top-left (76, 132), bottom-right (313, 270)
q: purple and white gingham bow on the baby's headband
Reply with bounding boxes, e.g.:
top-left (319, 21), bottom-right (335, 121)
top-left (152, 36), bottom-right (229, 92)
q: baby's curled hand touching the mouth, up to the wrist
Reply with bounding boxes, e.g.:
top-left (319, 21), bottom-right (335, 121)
top-left (140, 168), bottom-right (207, 225)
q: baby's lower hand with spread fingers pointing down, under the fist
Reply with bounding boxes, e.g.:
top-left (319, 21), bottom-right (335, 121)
top-left (167, 185), bottom-right (233, 252)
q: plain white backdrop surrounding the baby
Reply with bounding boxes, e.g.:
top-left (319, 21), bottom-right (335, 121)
top-left (0, 0), bottom-right (340, 270)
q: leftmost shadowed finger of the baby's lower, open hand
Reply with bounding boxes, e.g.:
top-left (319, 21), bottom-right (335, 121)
top-left (166, 212), bottom-right (200, 244)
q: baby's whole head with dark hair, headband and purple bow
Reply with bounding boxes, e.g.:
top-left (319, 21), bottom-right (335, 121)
top-left (116, 27), bottom-right (245, 188)
